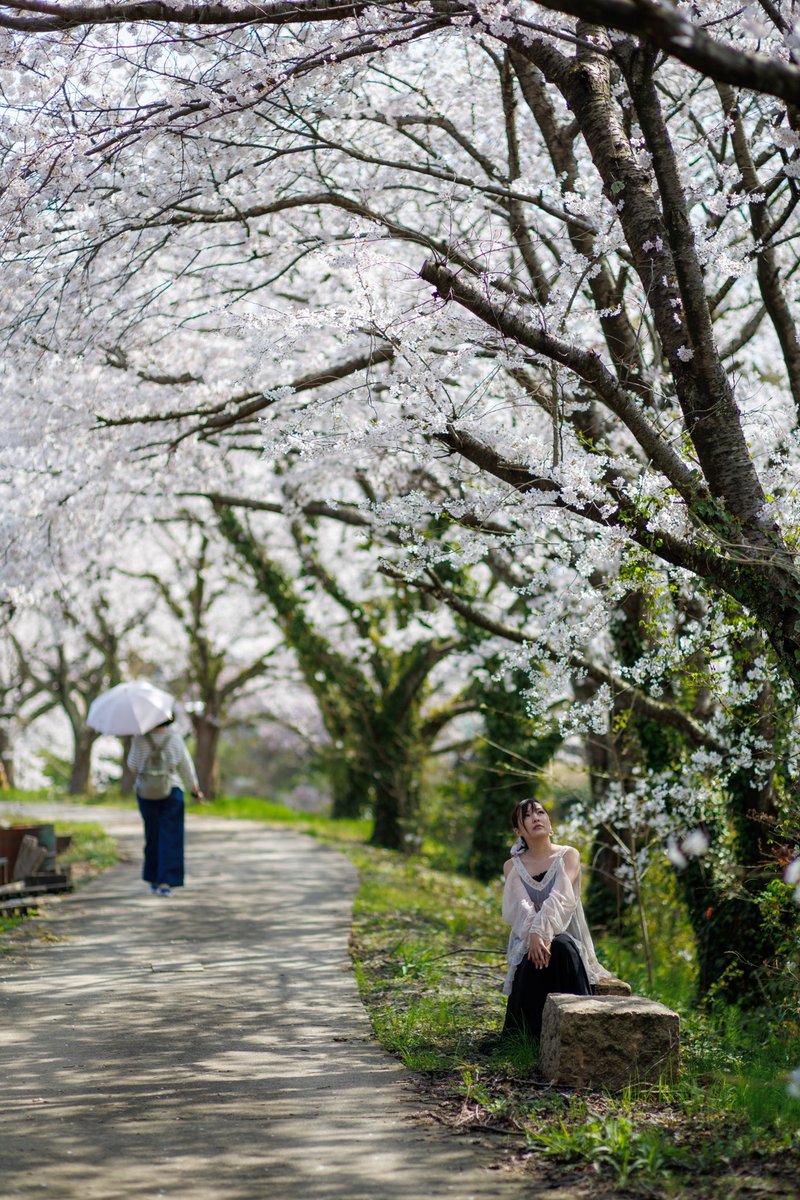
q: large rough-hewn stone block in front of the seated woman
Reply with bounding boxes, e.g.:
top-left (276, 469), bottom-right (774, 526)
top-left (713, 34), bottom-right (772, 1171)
top-left (539, 992), bottom-right (680, 1092)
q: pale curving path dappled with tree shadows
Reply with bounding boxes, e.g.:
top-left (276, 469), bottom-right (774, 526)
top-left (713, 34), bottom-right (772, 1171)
top-left (0, 805), bottom-right (528, 1200)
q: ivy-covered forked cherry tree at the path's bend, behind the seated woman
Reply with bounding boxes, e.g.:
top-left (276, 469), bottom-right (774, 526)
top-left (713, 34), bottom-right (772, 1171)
top-left (215, 498), bottom-right (475, 848)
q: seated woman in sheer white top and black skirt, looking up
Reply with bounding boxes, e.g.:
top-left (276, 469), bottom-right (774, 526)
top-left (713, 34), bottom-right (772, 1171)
top-left (503, 800), bottom-right (610, 1039)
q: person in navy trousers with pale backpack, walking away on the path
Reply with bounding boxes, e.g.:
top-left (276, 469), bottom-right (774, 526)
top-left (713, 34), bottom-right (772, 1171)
top-left (128, 716), bottom-right (203, 896)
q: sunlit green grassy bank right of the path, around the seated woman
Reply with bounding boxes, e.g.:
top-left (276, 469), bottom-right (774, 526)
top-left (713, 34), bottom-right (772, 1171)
top-left (3, 799), bottom-right (800, 1200)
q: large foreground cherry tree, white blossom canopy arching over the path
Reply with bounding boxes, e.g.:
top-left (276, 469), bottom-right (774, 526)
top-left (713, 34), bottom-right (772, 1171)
top-left (0, 0), bottom-right (800, 988)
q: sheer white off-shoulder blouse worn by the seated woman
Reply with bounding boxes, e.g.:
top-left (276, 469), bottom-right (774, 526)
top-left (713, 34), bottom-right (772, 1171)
top-left (503, 846), bottom-right (610, 996)
